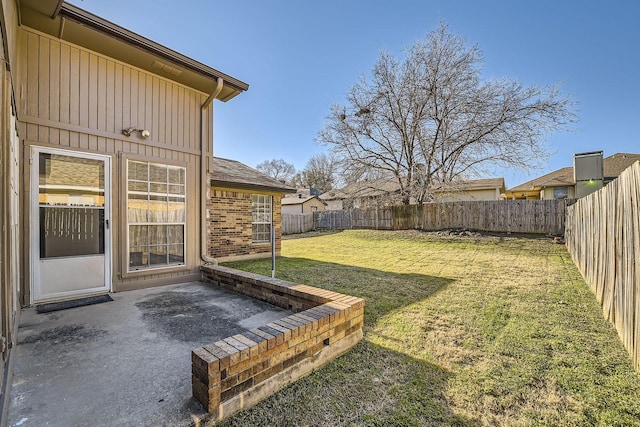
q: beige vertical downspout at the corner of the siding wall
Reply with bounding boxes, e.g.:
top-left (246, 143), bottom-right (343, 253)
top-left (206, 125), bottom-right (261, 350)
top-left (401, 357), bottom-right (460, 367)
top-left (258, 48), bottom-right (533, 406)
top-left (200, 77), bottom-right (224, 265)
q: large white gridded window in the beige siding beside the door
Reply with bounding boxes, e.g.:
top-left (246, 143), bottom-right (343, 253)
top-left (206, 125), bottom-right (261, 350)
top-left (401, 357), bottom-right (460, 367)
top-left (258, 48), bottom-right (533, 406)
top-left (127, 160), bottom-right (187, 271)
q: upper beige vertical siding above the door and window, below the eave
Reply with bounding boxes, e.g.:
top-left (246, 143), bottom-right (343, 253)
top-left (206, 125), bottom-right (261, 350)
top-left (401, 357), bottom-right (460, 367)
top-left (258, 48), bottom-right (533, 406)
top-left (19, 29), bottom-right (206, 153)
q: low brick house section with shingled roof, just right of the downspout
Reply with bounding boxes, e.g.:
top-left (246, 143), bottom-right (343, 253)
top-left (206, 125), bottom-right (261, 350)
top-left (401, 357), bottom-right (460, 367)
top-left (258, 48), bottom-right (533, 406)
top-left (208, 157), bottom-right (294, 261)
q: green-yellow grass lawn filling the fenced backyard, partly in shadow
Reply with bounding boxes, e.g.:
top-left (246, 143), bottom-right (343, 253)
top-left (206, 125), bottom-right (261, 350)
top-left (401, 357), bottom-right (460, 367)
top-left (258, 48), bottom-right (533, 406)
top-left (219, 230), bottom-right (640, 426)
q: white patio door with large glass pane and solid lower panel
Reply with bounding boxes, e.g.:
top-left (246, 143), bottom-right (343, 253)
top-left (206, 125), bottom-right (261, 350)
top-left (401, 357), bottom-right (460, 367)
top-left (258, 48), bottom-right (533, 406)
top-left (30, 147), bottom-right (111, 303)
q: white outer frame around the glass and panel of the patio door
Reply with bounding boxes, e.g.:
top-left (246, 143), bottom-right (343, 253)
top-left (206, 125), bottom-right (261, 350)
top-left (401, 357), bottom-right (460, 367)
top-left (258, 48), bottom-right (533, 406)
top-left (29, 145), bottom-right (114, 305)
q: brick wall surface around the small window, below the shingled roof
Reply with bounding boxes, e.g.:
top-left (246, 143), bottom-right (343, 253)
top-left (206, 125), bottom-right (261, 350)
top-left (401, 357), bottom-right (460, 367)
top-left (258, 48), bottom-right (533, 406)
top-left (208, 188), bottom-right (282, 258)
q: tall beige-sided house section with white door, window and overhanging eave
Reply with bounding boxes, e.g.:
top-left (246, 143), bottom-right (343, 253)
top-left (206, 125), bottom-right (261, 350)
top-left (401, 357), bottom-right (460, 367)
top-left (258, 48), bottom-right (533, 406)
top-left (0, 0), bottom-right (248, 394)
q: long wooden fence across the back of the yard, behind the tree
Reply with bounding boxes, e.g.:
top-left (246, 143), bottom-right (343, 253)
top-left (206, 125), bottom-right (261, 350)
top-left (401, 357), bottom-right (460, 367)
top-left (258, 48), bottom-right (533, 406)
top-left (290, 200), bottom-right (574, 234)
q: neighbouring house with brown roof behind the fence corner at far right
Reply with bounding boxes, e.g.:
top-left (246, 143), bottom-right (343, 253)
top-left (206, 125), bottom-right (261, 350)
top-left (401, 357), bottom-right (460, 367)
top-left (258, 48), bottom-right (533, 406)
top-left (505, 153), bottom-right (640, 200)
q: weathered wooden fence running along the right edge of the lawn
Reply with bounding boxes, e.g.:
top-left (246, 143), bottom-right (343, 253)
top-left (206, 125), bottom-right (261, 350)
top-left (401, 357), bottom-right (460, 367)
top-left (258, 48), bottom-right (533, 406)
top-left (566, 162), bottom-right (640, 369)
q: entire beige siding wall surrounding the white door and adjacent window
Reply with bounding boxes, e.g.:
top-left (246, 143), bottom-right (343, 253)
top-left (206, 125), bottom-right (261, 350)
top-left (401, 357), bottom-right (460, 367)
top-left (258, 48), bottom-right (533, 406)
top-left (17, 27), bottom-right (213, 302)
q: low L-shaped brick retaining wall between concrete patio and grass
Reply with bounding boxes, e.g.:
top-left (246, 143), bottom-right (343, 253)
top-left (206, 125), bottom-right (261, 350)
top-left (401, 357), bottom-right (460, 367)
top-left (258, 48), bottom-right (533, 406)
top-left (192, 266), bottom-right (364, 419)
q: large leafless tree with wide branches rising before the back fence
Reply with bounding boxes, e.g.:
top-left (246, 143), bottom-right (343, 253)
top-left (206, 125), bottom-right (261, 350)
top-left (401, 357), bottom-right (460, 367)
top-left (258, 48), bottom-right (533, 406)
top-left (318, 23), bottom-right (576, 203)
